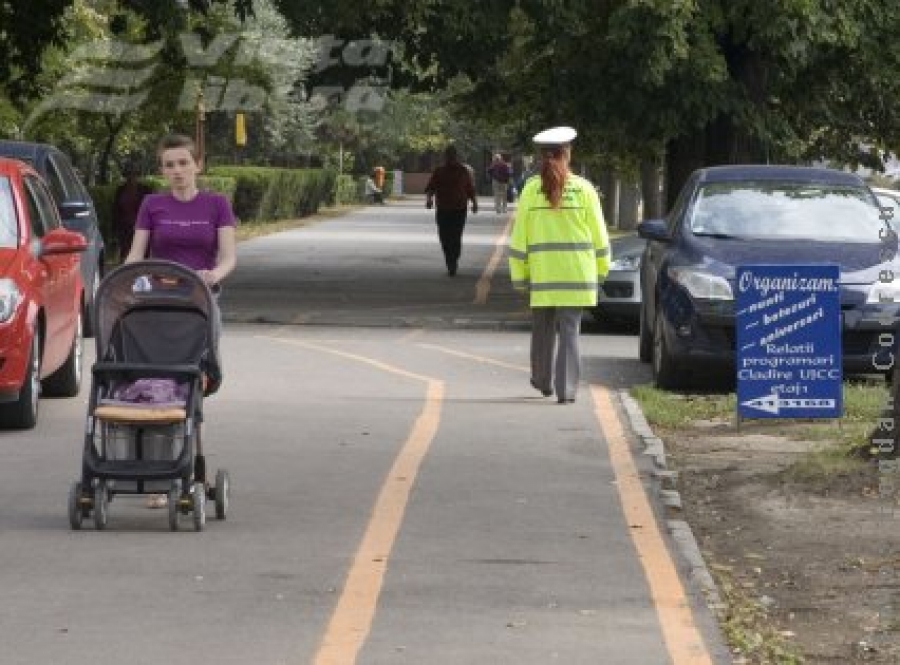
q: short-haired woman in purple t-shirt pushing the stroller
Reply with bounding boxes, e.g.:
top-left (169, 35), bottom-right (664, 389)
top-left (125, 134), bottom-right (236, 507)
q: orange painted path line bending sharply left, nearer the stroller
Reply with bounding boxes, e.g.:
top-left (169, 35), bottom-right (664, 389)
top-left (260, 337), bottom-right (444, 665)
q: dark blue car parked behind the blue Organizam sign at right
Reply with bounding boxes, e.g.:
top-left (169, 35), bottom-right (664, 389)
top-left (638, 166), bottom-right (900, 389)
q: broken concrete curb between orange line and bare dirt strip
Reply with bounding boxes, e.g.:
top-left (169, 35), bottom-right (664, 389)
top-left (619, 390), bottom-right (726, 616)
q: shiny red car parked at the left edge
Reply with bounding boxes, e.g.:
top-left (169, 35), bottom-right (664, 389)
top-left (0, 158), bottom-right (86, 429)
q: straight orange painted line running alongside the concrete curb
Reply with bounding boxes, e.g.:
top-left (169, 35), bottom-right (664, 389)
top-left (591, 385), bottom-right (712, 665)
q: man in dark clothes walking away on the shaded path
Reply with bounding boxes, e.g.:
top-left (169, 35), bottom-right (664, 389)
top-left (425, 145), bottom-right (478, 277)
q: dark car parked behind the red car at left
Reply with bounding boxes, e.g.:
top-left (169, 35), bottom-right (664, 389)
top-left (0, 141), bottom-right (105, 337)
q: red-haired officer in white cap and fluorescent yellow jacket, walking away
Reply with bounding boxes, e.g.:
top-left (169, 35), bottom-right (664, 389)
top-left (509, 127), bottom-right (612, 404)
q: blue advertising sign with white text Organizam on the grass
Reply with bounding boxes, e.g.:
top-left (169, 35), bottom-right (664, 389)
top-left (735, 265), bottom-right (842, 418)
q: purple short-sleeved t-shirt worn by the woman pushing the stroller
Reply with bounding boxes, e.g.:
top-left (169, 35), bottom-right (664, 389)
top-left (134, 192), bottom-right (235, 270)
